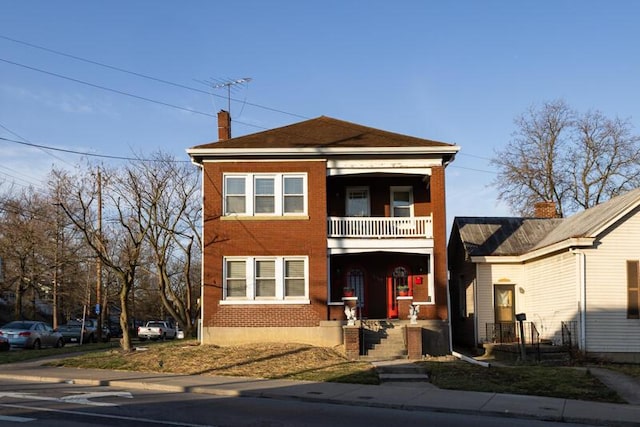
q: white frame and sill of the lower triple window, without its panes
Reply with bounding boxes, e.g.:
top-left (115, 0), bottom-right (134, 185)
top-left (220, 256), bottom-right (310, 305)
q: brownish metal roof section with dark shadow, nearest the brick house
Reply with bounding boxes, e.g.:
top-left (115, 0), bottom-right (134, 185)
top-left (453, 217), bottom-right (562, 256)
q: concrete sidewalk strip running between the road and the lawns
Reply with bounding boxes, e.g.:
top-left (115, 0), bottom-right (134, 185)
top-left (0, 362), bottom-right (640, 426)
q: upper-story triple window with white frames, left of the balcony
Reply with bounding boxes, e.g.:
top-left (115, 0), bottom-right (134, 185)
top-left (223, 173), bottom-right (307, 216)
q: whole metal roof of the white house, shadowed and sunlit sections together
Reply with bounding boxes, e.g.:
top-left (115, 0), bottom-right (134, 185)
top-left (453, 188), bottom-right (640, 256)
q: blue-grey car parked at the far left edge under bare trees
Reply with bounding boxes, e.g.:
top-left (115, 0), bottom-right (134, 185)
top-left (0, 320), bottom-right (64, 350)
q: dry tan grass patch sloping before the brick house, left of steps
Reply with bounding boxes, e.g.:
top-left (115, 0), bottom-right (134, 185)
top-left (53, 341), bottom-right (379, 384)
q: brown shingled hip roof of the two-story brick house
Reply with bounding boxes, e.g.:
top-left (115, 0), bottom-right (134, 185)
top-left (188, 116), bottom-right (458, 152)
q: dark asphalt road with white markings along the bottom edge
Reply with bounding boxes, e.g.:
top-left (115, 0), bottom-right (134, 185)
top-left (0, 380), bottom-right (596, 427)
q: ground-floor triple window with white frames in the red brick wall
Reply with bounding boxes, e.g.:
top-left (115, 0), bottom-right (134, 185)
top-left (223, 257), bottom-right (309, 301)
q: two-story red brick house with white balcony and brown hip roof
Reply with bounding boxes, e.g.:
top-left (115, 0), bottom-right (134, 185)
top-left (188, 111), bottom-right (459, 354)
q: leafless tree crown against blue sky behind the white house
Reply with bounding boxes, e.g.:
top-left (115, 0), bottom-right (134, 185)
top-left (491, 100), bottom-right (640, 216)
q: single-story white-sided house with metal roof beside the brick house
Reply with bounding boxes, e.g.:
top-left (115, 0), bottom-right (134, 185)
top-left (448, 189), bottom-right (640, 362)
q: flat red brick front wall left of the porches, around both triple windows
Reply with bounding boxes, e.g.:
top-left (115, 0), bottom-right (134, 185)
top-left (203, 162), bottom-right (327, 326)
